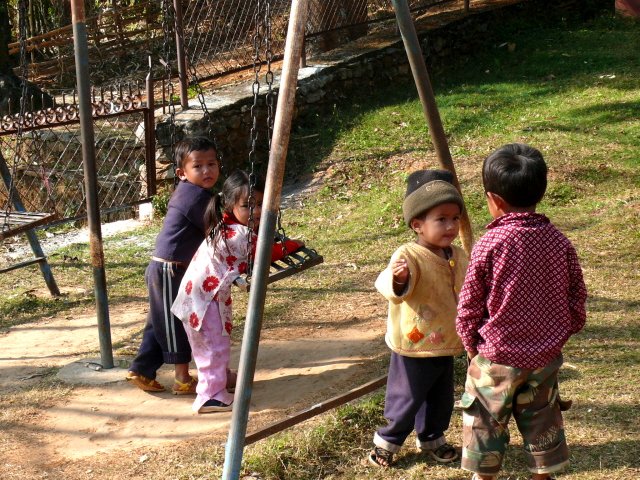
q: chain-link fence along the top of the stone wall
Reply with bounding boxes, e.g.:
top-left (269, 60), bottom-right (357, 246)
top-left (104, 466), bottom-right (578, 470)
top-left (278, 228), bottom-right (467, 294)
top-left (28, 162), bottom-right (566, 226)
top-left (183, 0), bottom-right (442, 79)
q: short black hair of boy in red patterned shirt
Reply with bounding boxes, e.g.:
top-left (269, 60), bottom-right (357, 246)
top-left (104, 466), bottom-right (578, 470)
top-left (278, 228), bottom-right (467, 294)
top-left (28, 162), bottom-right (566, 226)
top-left (482, 143), bottom-right (547, 208)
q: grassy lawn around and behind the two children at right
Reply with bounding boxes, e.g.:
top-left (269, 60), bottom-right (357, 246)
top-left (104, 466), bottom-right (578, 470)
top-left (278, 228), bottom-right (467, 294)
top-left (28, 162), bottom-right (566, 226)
top-left (231, 7), bottom-right (640, 480)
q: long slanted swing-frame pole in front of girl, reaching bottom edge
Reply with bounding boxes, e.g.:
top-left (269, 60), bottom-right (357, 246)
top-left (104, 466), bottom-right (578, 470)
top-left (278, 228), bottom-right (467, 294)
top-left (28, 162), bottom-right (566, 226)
top-left (222, 0), bottom-right (308, 480)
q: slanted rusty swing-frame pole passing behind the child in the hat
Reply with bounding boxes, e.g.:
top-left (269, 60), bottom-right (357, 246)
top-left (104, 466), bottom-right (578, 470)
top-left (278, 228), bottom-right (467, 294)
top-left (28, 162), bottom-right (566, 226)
top-left (391, 0), bottom-right (473, 253)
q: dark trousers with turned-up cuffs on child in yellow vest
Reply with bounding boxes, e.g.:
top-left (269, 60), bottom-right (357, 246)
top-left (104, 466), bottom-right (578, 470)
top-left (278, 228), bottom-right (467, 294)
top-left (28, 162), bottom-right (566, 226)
top-left (377, 352), bottom-right (453, 447)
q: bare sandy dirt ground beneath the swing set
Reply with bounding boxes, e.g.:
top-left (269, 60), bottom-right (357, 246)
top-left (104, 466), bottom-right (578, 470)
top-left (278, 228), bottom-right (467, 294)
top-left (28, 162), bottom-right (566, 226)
top-left (0, 288), bottom-right (386, 478)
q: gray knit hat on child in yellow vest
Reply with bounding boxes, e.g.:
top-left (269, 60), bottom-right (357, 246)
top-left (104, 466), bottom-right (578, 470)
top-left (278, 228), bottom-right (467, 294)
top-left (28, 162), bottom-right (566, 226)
top-left (402, 170), bottom-right (464, 226)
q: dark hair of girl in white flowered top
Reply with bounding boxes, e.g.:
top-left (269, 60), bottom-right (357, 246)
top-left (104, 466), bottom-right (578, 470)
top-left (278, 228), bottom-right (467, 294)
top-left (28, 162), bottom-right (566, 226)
top-left (204, 170), bottom-right (264, 241)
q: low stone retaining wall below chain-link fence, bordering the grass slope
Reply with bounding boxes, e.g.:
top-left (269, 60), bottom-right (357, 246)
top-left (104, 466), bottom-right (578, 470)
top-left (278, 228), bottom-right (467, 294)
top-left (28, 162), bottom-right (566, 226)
top-left (157, 0), bottom-right (574, 180)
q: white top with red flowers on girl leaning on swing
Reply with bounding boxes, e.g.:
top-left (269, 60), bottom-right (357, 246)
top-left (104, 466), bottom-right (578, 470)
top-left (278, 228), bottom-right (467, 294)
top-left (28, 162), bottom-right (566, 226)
top-left (171, 223), bottom-right (249, 336)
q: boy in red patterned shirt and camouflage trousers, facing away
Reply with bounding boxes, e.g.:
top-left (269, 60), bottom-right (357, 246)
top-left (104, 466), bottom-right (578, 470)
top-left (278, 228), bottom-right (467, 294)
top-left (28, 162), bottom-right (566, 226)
top-left (456, 143), bottom-right (587, 480)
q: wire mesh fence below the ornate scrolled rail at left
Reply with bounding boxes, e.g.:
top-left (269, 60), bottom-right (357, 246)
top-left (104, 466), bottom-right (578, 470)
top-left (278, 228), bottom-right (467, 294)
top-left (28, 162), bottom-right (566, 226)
top-left (0, 105), bottom-right (155, 223)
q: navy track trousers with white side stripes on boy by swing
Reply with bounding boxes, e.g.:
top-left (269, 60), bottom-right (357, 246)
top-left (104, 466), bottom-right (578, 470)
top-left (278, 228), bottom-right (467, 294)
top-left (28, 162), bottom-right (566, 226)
top-left (129, 261), bottom-right (191, 379)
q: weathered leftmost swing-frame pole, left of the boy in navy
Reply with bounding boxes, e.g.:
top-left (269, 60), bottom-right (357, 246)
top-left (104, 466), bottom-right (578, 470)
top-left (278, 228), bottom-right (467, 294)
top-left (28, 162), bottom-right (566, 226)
top-left (71, 0), bottom-right (113, 368)
